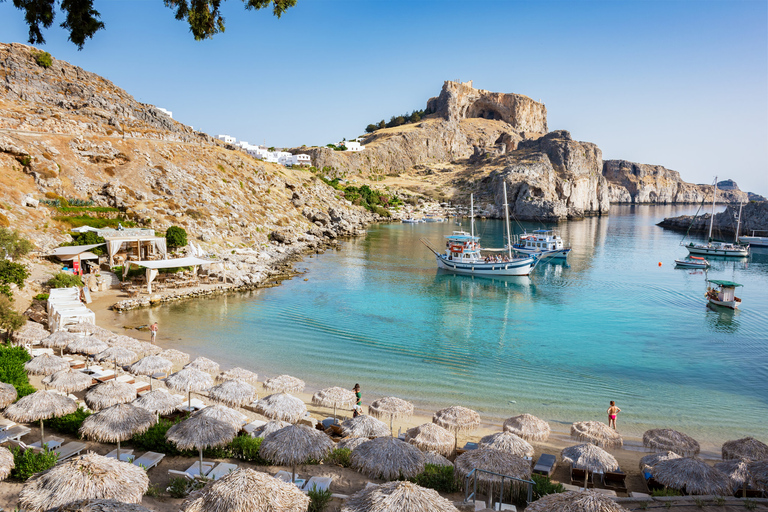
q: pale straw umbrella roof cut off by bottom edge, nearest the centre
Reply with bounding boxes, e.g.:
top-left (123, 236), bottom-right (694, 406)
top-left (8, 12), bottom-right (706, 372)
top-left (341, 482), bottom-right (458, 512)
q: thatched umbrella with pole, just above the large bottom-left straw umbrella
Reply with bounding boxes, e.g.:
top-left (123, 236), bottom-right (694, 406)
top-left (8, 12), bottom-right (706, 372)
top-left (79, 404), bottom-right (157, 460)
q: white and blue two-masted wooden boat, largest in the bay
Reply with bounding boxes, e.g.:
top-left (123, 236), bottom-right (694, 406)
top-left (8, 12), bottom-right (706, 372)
top-left (421, 186), bottom-right (541, 277)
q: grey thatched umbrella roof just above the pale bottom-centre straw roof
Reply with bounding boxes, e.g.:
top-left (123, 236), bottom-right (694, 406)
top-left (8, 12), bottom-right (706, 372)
top-left (349, 437), bottom-right (424, 480)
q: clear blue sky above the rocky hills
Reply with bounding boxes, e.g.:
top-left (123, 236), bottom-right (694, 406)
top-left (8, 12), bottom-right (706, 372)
top-left (0, 0), bottom-right (768, 196)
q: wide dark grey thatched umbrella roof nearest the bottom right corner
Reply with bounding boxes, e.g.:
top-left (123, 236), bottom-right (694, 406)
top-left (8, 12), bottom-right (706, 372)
top-left (651, 457), bottom-right (733, 496)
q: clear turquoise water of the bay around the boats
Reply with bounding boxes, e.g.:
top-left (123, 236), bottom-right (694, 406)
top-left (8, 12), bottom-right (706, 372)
top-left (108, 206), bottom-right (768, 446)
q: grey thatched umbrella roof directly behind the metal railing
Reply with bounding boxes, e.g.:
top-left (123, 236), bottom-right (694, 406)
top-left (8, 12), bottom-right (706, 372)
top-left (453, 448), bottom-right (531, 492)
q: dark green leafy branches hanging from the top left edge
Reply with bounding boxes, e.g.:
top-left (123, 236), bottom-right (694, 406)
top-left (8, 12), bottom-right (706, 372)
top-left (6, 0), bottom-right (296, 50)
